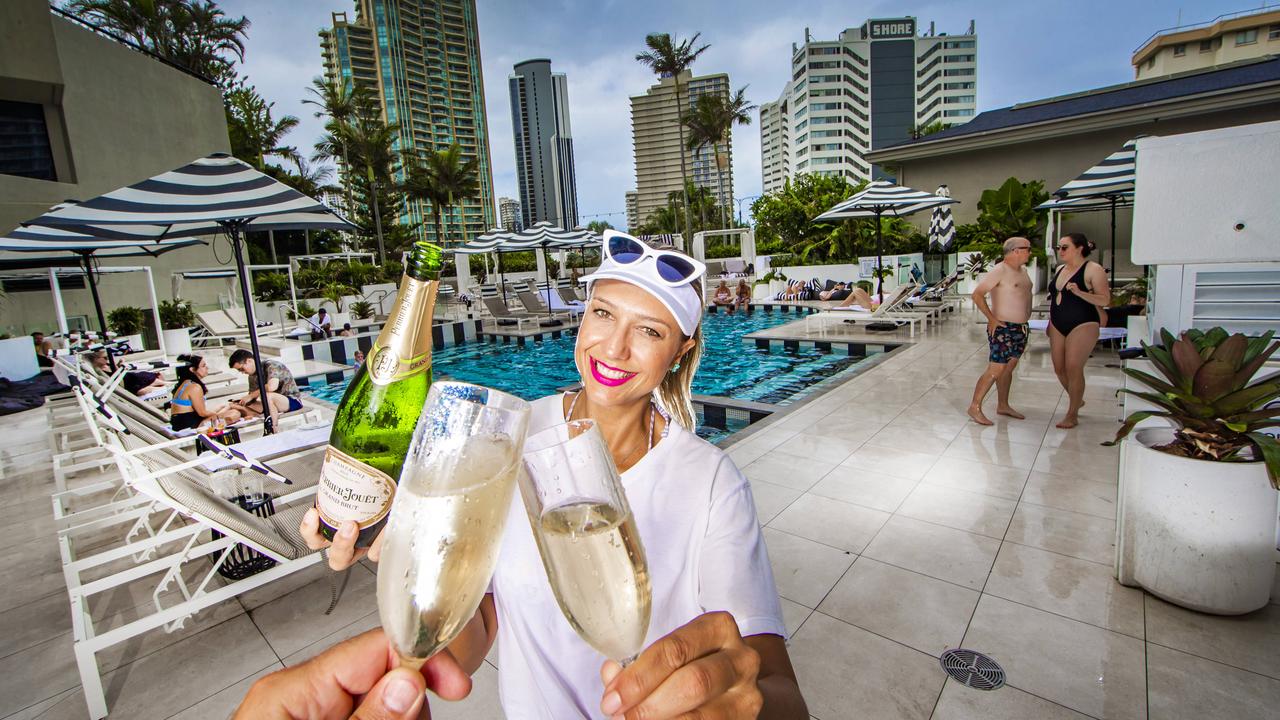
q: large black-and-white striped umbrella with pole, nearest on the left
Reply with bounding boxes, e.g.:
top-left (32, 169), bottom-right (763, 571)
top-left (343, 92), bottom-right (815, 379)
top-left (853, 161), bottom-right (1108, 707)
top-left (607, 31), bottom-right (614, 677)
top-left (24, 152), bottom-right (356, 433)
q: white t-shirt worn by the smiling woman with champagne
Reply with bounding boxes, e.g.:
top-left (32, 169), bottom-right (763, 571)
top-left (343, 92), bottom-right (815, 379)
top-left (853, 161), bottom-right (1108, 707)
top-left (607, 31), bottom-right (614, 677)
top-left (492, 395), bottom-right (786, 720)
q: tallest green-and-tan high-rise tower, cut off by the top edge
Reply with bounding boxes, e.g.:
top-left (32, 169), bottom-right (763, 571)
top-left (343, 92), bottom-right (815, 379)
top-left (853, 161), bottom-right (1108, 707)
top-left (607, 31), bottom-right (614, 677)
top-left (320, 0), bottom-right (494, 243)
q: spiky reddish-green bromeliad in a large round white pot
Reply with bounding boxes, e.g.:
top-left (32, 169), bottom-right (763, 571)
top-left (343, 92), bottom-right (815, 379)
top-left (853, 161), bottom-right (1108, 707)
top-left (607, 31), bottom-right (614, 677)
top-left (1105, 328), bottom-right (1280, 615)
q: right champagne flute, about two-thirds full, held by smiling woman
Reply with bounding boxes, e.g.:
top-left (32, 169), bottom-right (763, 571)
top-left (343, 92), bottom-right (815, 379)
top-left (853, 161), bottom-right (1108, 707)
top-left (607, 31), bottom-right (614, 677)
top-left (520, 420), bottom-right (652, 666)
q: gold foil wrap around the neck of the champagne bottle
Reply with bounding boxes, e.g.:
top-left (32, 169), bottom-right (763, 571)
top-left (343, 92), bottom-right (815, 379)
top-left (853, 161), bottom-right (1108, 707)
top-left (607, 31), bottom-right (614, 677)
top-left (367, 275), bottom-right (435, 386)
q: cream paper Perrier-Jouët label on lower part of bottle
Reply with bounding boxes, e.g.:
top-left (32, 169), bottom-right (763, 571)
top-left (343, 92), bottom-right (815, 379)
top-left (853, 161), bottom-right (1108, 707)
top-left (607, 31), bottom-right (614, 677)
top-left (316, 445), bottom-right (396, 529)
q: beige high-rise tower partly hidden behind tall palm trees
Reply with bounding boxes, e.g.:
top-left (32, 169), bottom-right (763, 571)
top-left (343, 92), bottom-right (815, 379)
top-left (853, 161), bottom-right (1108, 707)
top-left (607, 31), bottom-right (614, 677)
top-left (631, 72), bottom-right (733, 229)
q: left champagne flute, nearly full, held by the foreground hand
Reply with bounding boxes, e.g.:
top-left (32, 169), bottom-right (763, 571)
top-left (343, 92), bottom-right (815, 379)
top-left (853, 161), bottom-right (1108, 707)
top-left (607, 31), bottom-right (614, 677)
top-left (378, 382), bottom-right (529, 669)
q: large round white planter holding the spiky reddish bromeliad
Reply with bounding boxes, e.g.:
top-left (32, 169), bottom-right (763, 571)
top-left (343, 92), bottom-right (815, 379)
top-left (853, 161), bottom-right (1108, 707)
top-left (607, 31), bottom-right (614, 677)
top-left (1116, 428), bottom-right (1280, 615)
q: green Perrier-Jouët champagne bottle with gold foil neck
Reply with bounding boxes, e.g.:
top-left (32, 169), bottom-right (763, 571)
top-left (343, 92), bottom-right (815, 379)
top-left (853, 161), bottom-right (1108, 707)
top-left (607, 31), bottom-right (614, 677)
top-left (316, 242), bottom-right (442, 547)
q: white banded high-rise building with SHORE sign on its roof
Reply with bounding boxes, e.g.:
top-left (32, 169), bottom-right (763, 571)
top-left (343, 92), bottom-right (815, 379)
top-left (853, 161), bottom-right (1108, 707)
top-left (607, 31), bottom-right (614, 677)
top-left (760, 18), bottom-right (978, 192)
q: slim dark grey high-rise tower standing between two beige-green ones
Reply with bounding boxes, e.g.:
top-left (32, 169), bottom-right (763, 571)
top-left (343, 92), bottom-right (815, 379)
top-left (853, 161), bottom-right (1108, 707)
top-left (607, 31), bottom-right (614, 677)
top-left (508, 59), bottom-right (577, 228)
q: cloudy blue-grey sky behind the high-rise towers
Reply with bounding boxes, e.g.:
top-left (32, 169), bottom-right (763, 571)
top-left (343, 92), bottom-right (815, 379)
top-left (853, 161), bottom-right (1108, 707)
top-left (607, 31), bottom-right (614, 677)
top-left (219, 0), bottom-right (1249, 225)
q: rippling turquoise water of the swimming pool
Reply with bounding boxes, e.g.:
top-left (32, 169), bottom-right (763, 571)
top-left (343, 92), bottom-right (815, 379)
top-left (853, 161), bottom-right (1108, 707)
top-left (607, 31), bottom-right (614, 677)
top-left (305, 310), bottom-right (865, 442)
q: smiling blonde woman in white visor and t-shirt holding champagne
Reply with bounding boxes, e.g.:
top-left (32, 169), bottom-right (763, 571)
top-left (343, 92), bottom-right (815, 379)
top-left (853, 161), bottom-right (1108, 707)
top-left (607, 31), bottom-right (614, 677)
top-left (294, 231), bottom-right (808, 720)
